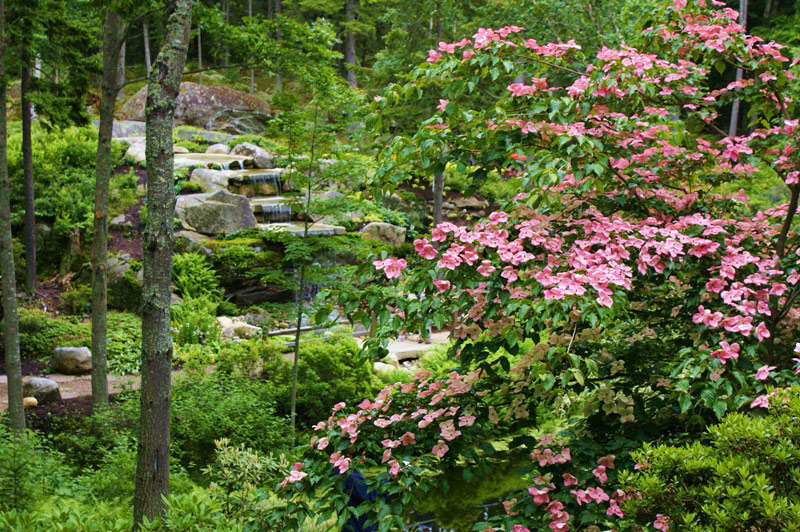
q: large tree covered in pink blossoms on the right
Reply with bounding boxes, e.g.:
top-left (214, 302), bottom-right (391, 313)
top-left (276, 0), bottom-right (800, 530)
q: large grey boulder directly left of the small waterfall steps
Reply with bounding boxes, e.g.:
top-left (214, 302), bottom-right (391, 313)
top-left (175, 190), bottom-right (258, 235)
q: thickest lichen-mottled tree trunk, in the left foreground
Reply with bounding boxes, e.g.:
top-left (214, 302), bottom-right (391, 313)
top-left (133, 0), bottom-right (192, 529)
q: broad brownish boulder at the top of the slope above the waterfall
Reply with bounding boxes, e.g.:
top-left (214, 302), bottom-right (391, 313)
top-left (122, 81), bottom-right (270, 133)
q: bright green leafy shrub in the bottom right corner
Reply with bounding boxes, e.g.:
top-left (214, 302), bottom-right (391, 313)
top-left (620, 389), bottom-right (800, 530)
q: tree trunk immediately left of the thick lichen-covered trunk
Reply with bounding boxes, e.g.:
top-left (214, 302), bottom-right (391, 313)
top-left (92, 7), bottom-right (122, 410)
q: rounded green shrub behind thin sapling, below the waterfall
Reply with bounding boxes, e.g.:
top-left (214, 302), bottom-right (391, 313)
top-left (264, 332), bottom-right (377, 428)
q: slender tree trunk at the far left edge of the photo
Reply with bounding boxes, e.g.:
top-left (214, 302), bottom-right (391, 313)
top-left (0, 0), bottom-right (25, 433)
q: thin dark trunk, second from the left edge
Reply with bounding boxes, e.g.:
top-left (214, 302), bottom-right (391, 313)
top-left (20, 43), bottom-right (36, 295)
